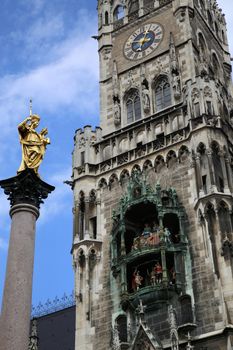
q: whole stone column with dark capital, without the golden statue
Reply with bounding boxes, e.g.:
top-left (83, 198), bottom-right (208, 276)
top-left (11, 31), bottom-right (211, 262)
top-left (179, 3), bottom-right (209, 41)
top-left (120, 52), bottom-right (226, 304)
top-left (0, 169), bottom-right (54, 350)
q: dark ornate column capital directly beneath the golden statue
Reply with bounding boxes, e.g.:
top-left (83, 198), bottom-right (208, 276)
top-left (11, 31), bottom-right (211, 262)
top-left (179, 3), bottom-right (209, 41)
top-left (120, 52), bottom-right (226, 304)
top-left (0, 169), bottom-right (55, 209)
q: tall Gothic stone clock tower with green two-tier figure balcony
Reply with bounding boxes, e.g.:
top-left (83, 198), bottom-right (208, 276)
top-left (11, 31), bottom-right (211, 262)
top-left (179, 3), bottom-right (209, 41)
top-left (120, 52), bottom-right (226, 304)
top-left (72, 0), bottom-right (233, 350)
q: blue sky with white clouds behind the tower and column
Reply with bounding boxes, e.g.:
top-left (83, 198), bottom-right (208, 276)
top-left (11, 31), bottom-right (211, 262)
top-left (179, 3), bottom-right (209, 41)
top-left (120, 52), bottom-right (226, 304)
top-left (0, 0), bottom-right (233, 305)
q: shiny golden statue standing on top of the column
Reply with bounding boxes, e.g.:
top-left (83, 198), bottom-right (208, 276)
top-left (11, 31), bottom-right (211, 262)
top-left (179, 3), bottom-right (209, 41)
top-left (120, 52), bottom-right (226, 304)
top-left (18, 114), bottom-right (50, 175)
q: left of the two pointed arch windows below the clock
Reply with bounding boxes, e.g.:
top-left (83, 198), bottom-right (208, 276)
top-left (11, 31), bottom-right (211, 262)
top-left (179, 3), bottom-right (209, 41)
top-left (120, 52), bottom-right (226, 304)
top-left (126, 90), bottom-right (142, 124)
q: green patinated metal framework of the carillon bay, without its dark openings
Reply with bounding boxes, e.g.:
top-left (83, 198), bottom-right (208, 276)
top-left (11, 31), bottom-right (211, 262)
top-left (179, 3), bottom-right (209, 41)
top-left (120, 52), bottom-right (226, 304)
top-left (111, 171), bottom-right (188, 309)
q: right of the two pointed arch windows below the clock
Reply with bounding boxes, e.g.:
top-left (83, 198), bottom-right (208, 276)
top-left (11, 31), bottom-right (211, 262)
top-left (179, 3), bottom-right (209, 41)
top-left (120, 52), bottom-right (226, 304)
top-left (155, 77), bottom-right (172, 111)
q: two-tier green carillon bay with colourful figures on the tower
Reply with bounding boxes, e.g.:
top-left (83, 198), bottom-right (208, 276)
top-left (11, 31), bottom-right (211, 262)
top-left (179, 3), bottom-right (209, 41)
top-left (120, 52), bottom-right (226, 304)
top-left (111, 171), bottom-right (187, 308)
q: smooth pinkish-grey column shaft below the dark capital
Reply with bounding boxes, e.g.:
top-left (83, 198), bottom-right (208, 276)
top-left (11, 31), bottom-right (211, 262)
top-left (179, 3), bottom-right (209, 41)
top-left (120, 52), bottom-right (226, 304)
top-left (0, 204), bottom-right (39, 350)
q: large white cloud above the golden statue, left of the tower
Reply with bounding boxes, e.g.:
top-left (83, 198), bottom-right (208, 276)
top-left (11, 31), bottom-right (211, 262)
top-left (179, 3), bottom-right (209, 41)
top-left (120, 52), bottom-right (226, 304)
top-left (0, 12), bottom-right (98, 163)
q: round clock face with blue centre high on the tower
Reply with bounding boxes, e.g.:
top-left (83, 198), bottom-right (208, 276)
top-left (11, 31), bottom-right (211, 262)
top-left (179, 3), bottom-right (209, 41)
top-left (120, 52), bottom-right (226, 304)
top-left (124, 23), bottom-right (163, 60)
